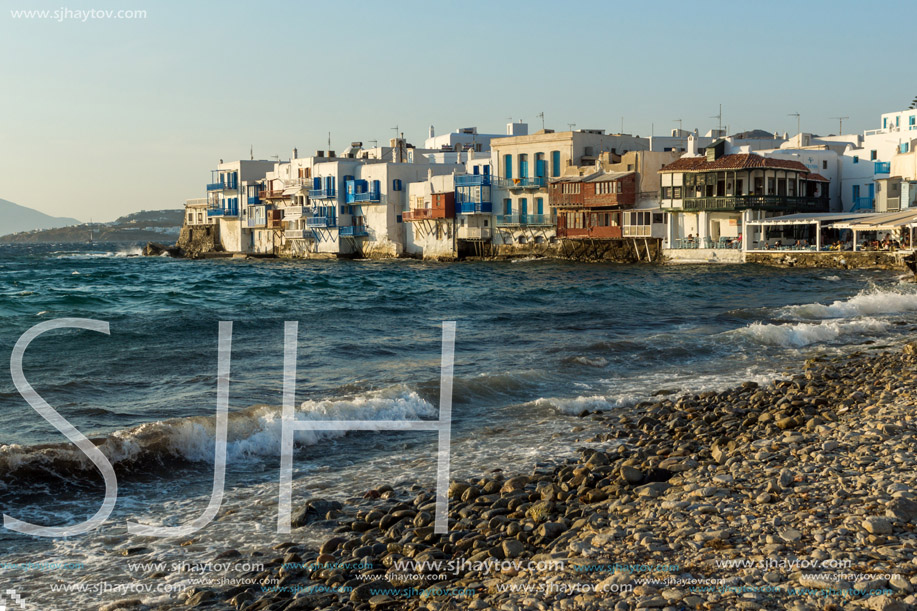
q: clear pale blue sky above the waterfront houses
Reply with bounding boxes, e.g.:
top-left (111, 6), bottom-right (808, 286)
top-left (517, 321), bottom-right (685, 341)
top-left (0, 0), bottom-right (917, 224)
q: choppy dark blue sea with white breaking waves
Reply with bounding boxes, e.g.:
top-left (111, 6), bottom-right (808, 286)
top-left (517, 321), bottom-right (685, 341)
top-left (0, 244), bottom-right (917, 610)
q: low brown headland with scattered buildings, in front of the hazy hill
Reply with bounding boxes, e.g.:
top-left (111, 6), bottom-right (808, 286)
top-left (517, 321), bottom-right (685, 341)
top-left (0, 210), bottom-right (184, 244)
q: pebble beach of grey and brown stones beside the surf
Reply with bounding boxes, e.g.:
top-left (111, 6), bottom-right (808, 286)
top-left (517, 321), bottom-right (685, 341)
top-left (109, 344), bottom-right (917, 611)
